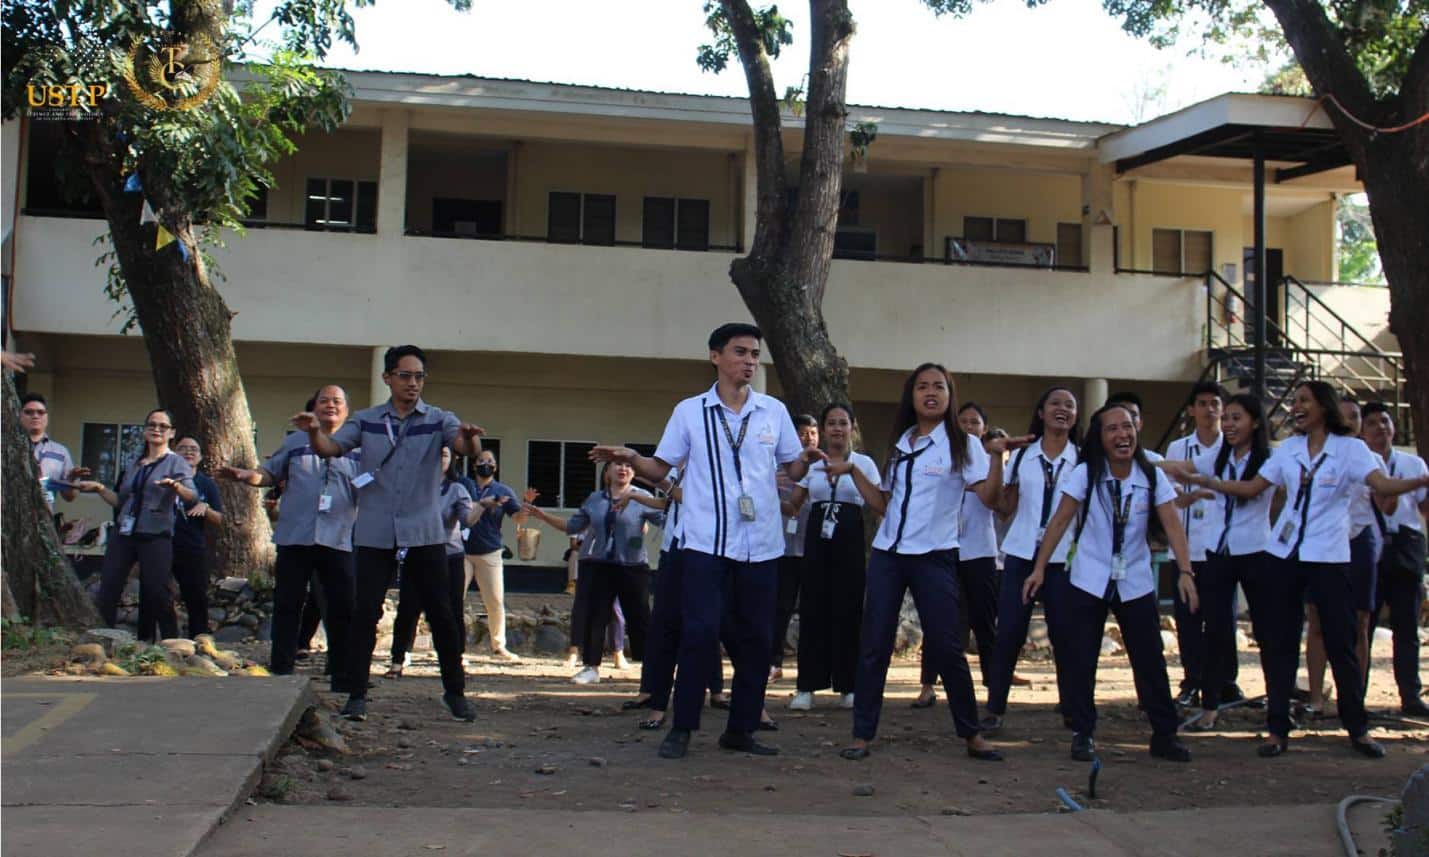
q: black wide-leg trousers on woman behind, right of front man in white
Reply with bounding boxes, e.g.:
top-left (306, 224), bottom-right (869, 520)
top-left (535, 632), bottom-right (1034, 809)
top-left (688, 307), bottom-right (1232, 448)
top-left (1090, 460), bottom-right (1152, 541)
top-left (800, 503), bottom-right (867, 694)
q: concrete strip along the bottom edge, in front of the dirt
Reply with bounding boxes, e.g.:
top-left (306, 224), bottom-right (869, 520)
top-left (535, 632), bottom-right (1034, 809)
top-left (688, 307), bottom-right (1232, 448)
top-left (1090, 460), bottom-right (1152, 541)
top-left (199, 804), bottom-right (1372, 857)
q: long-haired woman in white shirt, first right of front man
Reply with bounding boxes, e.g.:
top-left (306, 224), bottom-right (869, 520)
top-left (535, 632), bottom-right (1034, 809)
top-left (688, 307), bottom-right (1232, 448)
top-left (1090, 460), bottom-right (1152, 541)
top-left (827, 363), bottom-right (1026, 761)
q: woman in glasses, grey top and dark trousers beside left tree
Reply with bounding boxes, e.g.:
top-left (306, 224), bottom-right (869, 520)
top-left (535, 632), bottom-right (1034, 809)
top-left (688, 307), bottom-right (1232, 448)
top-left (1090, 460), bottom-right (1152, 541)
top-left (74, 407), bottom-right (199, 640)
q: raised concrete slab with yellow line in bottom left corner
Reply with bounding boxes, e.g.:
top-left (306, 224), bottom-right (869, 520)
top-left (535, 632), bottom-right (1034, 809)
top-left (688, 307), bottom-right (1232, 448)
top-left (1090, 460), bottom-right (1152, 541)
top-left (0, 677), bottom-right (312, 857)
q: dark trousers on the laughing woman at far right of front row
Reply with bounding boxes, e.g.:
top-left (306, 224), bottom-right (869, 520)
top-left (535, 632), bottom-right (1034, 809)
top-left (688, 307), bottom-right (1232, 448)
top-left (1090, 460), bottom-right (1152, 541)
top-left (1255, 558), bottom-right (1369, 738)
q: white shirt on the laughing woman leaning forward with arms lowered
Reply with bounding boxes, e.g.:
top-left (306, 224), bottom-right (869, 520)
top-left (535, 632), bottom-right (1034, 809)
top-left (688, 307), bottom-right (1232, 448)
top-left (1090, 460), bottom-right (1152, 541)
top-left (1062, 461), bottom-right (1176, 601)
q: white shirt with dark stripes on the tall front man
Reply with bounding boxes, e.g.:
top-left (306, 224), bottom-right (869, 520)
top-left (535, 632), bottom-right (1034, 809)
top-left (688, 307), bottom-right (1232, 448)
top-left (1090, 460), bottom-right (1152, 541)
top-left (654, 386), bottom-right (803, 563)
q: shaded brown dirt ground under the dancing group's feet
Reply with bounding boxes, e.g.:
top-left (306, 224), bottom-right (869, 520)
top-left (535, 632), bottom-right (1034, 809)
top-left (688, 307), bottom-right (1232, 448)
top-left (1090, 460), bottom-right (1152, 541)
top-left (259, 625), bottom-right (1429, 816)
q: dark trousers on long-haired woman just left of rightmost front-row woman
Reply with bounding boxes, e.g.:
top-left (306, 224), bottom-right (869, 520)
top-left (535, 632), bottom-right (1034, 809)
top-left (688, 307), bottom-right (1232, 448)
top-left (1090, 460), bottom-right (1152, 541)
top-left (1200, 553), bottom-right (1275, 710)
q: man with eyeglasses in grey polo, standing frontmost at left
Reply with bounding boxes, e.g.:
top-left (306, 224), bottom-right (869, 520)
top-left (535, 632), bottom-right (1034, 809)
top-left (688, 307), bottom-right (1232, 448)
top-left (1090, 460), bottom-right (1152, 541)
top-left (293, 346), bottom-right (484, 721)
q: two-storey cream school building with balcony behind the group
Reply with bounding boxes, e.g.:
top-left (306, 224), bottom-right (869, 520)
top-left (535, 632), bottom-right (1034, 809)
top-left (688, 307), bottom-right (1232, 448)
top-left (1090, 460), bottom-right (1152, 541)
top-left (3, 71), bottom-right (1403, 563)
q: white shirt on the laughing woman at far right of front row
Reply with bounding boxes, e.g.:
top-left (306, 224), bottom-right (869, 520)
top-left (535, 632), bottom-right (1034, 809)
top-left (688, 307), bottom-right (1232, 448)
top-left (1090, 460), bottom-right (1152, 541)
top-left (1260, 434), bottom-right (1383, 563)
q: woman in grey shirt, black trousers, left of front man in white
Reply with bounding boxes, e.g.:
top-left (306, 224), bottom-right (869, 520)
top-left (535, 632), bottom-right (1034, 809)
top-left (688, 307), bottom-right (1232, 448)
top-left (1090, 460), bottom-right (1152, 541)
top-left (524, 461), bottom-right (664, 684)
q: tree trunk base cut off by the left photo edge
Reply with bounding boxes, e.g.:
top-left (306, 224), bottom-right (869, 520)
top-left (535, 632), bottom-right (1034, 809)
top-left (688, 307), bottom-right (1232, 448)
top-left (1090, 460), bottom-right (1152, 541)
top-left (0, 371), bottom-right (100, 628)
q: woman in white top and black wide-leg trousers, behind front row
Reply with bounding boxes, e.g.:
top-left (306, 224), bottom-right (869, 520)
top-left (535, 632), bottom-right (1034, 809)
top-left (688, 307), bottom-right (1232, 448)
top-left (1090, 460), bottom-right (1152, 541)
top-left (789, 401), bottom-right (879, 711)
